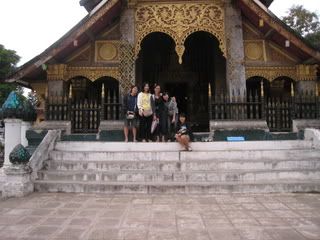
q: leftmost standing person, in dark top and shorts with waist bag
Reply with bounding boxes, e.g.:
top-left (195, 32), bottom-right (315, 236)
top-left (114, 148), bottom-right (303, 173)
top-left (122, 86), bottom-right (138, 142)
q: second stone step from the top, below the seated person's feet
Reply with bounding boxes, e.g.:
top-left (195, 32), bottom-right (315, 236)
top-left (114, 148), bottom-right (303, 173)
top-left (50, 149), bottom-right (320, 162)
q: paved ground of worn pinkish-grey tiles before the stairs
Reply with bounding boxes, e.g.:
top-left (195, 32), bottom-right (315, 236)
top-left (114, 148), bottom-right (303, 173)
top-left (0, 193), bottom-right (320, 240)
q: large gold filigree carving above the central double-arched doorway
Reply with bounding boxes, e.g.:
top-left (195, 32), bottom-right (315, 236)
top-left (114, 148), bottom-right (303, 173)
top-left (135, 0), bottom-right (226, 63)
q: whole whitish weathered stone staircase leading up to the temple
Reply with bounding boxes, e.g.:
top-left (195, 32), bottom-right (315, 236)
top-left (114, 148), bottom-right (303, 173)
top-left (35, 140), bottom-right (320, 193)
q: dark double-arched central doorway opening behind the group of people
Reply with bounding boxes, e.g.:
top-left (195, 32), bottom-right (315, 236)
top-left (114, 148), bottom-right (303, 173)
top-left (136, 32), bottom-right (226, 132)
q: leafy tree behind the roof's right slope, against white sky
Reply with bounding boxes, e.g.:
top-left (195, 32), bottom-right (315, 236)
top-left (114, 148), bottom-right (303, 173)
top-left (282, 5), bottom-right (320, 49)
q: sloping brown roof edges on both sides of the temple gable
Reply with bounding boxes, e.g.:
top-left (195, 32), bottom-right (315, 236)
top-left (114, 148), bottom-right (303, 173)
top-left (6, 0), bottom-right (320, 87)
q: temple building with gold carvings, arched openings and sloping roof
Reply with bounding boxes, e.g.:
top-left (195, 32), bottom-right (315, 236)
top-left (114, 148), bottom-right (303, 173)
top-left (7, 0), bottom-right (320, 133)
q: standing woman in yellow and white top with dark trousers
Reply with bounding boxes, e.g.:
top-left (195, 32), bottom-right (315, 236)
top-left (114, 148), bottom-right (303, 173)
top-left (137, 83), bottom-right (156, 142)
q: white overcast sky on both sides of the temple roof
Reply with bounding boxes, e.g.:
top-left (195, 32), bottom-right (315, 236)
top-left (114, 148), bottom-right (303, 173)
top-left (0, 0), bottom-right (320, 65)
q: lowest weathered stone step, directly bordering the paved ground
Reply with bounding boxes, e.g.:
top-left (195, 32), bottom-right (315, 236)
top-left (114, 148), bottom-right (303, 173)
top-left (34, 180), bottom-right (320, 194)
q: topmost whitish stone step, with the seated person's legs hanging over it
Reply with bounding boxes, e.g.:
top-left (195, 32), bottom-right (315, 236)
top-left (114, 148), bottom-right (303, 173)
top-left (55, 140), bottom-right (312, 152)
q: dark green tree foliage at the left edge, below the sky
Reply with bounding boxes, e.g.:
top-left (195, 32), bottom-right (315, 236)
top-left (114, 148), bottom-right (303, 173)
top-left (0, 44), bottom-right (20, 81)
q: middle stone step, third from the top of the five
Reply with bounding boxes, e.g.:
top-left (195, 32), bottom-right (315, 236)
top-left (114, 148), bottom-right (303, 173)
top-left (46, 158), bottom-right (320, 172)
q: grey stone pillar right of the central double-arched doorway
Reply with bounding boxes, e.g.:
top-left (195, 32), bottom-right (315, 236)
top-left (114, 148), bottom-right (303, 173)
top-left (225, 0), bottom-right (246, 94)
